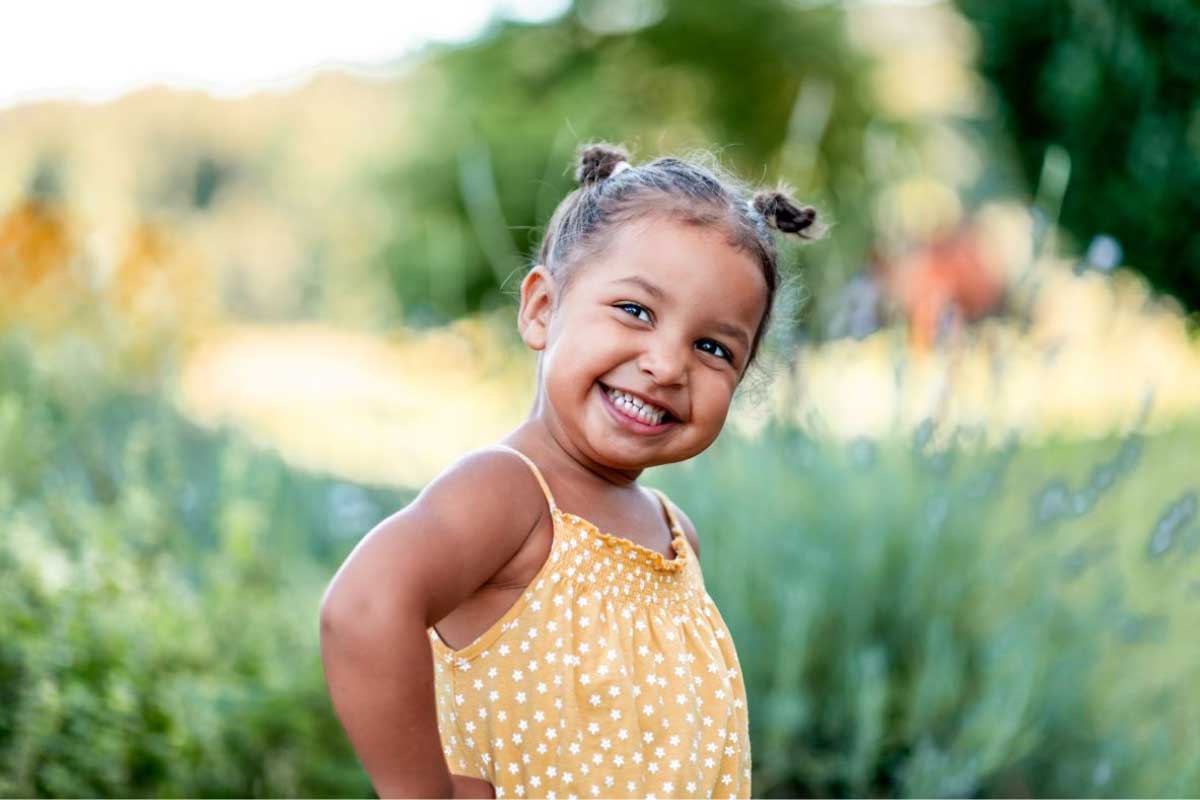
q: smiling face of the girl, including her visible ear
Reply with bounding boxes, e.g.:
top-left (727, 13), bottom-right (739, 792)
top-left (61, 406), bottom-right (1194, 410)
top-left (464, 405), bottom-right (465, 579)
top-left (520, 217), bottom-right (767, 471)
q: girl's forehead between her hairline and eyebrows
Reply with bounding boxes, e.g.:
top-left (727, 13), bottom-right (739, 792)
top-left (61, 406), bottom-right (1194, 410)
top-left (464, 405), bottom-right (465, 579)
top-left (581, 217), bottom-right (767, 326)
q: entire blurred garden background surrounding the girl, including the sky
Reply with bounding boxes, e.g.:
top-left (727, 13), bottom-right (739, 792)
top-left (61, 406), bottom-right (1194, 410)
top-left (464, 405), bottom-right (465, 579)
top-left (0, 0), bottom-right (1200, 798)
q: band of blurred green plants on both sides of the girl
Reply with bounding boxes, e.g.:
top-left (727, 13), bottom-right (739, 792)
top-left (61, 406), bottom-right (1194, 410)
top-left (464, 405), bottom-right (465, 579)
top-left (0, 319), bottom-right (1200, 798)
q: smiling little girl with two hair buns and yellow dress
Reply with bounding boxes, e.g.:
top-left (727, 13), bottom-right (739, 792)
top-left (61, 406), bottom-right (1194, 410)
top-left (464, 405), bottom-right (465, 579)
top-left (320, 145), bottom-right (816, 800)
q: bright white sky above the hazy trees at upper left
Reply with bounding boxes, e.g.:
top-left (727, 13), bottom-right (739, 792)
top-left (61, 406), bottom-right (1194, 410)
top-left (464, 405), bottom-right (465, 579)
top-left (0, 0), bottom-right (568, 109)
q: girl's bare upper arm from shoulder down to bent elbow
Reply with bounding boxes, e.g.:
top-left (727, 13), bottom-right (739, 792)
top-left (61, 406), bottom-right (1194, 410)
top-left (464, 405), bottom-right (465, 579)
top-left (326, 447), bottom-right (548, 626)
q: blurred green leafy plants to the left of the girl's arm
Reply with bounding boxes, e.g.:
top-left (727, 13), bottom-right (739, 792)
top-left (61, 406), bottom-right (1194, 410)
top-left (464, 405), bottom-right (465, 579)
top-left (0, 335), bottom-right (407, 796)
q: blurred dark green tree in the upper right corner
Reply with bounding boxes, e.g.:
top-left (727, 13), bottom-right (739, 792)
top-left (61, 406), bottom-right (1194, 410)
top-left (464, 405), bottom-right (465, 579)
top-left (956, 0), bottom-right (1200, 309)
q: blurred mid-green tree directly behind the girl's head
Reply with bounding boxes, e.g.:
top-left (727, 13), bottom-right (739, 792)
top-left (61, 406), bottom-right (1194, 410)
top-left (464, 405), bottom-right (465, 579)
top-left (380, 0), bottom-right (872, 335)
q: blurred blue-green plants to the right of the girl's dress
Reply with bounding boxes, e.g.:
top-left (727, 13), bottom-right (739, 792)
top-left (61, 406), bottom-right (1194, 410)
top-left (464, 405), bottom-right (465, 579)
top-left (659, 417), bottom-right (1200, 796)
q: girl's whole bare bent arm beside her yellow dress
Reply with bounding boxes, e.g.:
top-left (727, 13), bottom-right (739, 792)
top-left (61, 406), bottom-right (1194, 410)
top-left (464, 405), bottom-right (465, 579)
top-left (320, 450), bottom-right (545, 798)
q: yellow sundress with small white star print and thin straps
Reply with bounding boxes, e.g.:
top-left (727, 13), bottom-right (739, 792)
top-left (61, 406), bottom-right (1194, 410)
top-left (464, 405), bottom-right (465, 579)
top-left (428, 445), bottom-right (750, 800)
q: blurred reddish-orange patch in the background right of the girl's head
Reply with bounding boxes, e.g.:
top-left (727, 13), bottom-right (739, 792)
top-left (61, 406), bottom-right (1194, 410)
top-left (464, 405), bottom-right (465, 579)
top-left (876, 227), bottom-right (1004, 350)
